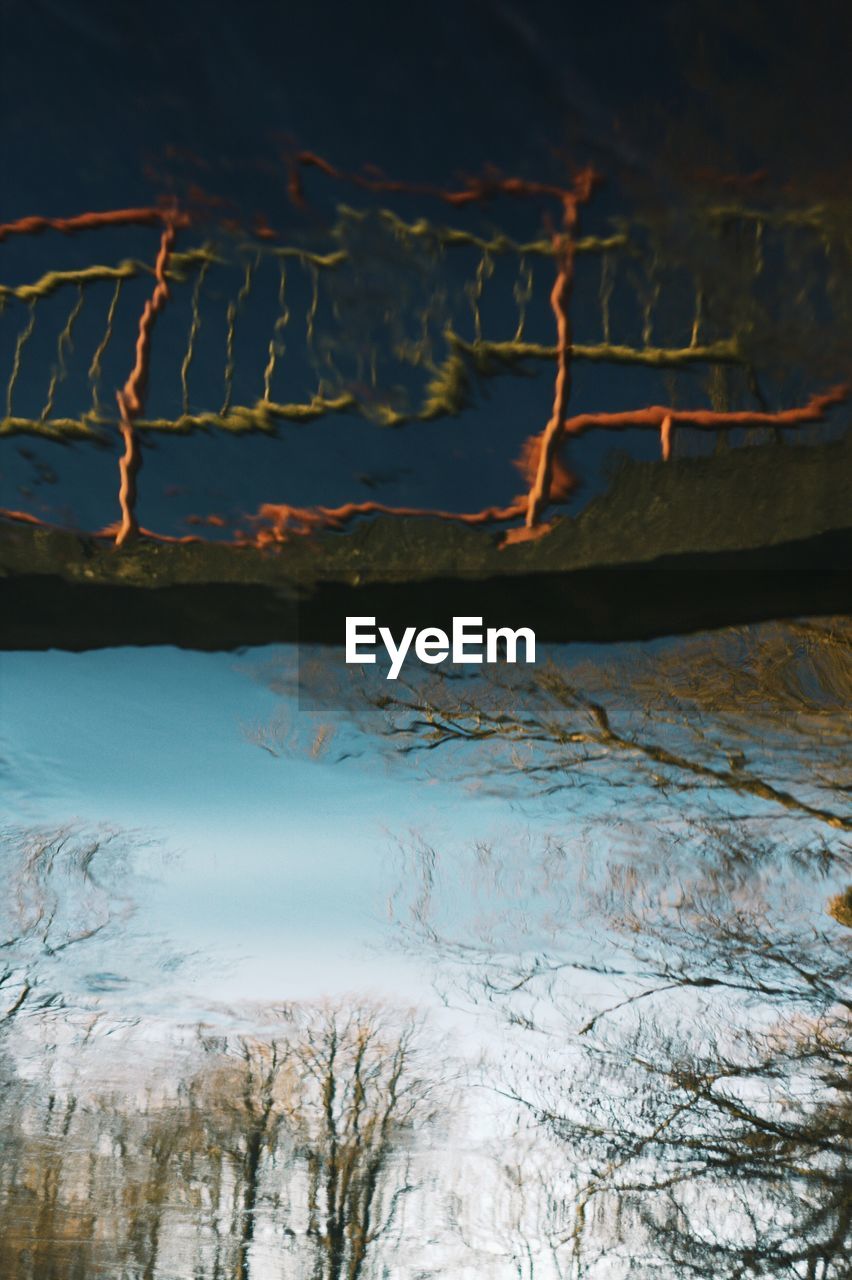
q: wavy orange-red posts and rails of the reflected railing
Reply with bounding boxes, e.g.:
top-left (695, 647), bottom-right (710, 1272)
top-left (6, 167), bottom-right (849, 547)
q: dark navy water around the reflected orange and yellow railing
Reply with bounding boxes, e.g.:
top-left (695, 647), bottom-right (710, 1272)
top-left (0, 0), bottom-right (852, 538)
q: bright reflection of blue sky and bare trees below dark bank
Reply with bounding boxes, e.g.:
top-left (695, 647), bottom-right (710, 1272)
top-left (0, 621), bottom-right (852, 1280)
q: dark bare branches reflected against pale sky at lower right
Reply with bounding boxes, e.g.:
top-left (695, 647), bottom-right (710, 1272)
top-left (388, 828), bottom-right (852, 1280)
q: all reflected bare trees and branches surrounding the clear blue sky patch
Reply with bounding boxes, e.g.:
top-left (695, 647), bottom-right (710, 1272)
top-left (0, 623), bottom-right (852, 1280)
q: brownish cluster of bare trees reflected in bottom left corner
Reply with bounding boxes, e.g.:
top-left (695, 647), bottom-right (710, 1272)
top-left (0, 1000), bottom-right (450, 1280)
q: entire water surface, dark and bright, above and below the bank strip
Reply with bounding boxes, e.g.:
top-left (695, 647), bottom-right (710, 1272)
top-left (0, 0), bottom-right (852, 1280)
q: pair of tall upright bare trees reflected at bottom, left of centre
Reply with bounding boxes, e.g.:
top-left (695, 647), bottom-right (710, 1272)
top-left (192, 1004), bottom-right (435, 1280)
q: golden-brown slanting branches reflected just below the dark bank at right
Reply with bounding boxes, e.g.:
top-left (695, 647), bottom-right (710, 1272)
top-left (249, 618), bottom-right (852, 831)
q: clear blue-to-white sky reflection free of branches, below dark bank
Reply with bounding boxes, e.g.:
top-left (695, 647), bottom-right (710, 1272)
top-left (0, 648), bottom-right (521, 1000)
